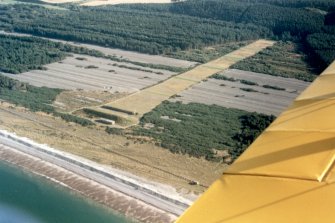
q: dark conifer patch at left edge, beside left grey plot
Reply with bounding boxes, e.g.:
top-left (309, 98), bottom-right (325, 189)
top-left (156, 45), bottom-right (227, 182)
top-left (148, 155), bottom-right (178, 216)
top-left (0, 34), bottom-right (103, 74)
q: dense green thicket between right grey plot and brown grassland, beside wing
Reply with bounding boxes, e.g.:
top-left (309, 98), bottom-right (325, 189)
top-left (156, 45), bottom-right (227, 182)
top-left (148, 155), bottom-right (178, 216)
top-left (133, 101), bottom-right (274, 160)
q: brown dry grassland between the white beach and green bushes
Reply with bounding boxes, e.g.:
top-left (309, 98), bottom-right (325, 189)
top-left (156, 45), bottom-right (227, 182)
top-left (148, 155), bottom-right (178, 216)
top-left (0, 106), bottom-right (226, 194)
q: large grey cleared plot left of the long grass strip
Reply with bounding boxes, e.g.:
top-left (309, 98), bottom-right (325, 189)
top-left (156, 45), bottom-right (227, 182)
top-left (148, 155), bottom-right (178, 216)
top-left (6, 54), bottom-right (178, 92)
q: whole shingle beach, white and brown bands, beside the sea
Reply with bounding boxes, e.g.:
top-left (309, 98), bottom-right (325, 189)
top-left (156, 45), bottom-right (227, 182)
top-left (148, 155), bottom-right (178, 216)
top-left (0, 130), bottom-right (192, 223)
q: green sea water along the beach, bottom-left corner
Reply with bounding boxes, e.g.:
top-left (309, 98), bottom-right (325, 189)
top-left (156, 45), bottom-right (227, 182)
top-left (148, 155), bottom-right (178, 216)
top-left (0, 161), bottom-right (131, 223)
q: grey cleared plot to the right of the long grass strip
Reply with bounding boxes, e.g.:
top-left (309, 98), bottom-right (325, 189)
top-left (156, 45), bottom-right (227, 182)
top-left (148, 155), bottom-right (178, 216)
top-left (170, 70), bottom-right (310, 115)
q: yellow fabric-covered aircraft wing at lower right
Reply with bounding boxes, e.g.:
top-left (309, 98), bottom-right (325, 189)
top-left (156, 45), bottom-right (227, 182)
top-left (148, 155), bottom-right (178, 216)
top-left (176, 62), bottom-right (335, 223)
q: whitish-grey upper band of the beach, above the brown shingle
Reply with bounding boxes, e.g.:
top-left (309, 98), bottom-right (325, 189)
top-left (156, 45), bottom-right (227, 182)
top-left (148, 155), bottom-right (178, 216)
top-left (0, 130), bottom-right (192, 216)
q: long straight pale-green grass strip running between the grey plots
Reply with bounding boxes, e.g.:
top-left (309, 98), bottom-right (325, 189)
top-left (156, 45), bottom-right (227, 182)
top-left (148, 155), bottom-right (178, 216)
top-left (102, 40), bottom-right (274, 122)
